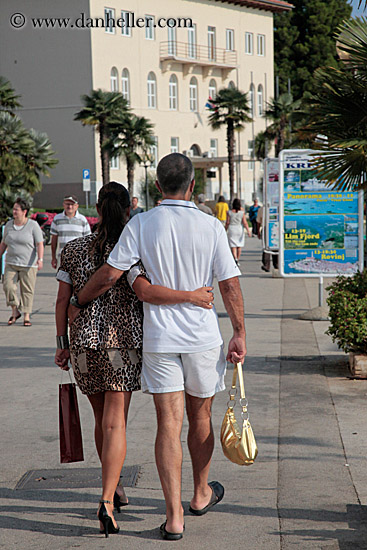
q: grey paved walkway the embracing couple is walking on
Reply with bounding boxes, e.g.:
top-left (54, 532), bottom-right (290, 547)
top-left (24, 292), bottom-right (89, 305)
top-left (0, 239), bottom-right (367, 550)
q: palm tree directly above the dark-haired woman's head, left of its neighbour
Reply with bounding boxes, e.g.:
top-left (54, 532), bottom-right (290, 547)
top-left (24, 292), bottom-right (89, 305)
top-left (74, 89), bottom-right (129, 185)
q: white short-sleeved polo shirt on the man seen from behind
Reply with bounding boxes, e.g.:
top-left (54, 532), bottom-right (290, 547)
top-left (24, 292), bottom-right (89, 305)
top-left (107, 199), bottom-right (240, 353)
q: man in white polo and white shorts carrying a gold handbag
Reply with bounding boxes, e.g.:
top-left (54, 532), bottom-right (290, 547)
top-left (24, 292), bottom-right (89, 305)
top-left (72, 153), bottom-right (246, 540)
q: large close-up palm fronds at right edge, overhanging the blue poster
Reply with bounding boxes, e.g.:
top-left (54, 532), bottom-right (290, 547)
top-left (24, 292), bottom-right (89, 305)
top-left (305, 19), bottom-right (367, 190)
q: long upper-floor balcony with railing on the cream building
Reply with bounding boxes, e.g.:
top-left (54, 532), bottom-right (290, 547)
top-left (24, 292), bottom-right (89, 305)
top-left (159, 41), bottom-right (237, 76)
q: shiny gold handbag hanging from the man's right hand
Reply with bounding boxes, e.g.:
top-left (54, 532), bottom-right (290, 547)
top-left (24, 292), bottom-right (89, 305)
top-left (220, 363), bottom-right (257, 466)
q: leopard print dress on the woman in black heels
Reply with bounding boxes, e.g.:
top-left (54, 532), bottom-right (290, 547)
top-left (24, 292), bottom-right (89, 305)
top-left (57, 234), bottom-right (145, 395)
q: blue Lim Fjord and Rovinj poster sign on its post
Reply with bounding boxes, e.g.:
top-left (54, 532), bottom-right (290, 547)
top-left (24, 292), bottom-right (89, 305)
top-left (279, 149), bottom-right (363, 320)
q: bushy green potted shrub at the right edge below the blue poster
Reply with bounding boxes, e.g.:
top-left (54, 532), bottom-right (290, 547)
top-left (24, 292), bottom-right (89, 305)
top-left (326, 270), bottom-right (367, 378)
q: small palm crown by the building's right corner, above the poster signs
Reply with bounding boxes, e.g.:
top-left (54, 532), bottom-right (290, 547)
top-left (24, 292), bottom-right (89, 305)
top-left (264, 93), bottom-right (301, 157)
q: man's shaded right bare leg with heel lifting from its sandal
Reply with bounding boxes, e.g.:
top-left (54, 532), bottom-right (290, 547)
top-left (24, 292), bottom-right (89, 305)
top-left (186, 393), bottom-right (214, 510)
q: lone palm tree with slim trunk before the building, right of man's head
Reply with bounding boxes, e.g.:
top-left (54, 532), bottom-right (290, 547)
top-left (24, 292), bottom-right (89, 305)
top-left (209, 88), bottom-right (252, 201)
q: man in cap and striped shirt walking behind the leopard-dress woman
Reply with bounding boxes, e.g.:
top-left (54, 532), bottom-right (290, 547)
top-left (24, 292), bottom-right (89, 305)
top-left (50, 195), bottom-right (90, 269)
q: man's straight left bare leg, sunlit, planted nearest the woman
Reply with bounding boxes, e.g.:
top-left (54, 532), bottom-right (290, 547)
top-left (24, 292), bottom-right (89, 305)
top-left (154, 391), bottom-right (184, 533)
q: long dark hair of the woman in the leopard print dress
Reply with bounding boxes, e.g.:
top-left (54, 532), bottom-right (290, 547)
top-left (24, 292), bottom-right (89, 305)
top-left (92, 181), bottom-right (130, 264)
